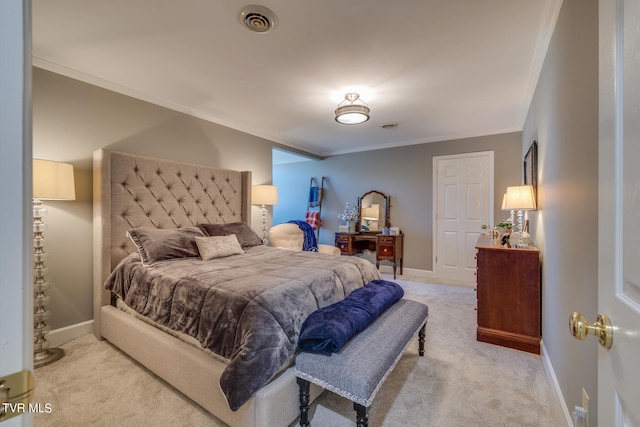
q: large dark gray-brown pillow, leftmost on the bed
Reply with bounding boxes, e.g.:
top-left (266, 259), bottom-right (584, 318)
top-left (127, 227), bottom-right (204, 265)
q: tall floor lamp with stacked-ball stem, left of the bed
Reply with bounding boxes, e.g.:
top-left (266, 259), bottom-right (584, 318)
top-left (33, 159), bottom-right (76, 368)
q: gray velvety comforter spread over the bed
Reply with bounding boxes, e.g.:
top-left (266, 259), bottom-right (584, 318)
top-left (105, 246), bottom-right (380, 411)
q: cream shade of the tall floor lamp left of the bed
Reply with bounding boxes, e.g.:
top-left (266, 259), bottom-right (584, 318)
top-left (33, 159), bottom-right (76, 200)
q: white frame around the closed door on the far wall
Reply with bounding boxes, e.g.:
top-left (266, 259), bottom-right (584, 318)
top-left (431, 150), bottom-right (495, 285)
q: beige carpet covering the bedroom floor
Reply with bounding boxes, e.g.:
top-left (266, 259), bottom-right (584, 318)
top-left (34, 280), bottom-right (566, 427)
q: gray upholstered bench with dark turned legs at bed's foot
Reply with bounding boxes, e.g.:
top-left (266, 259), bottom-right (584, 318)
top-left (294, 299), bottom-right (429, 427)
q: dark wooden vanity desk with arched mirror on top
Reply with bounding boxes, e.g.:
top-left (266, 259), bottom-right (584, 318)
top-left (335, 191), bottom-right (404, 279)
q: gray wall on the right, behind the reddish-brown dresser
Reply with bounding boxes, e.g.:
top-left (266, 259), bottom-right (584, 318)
top-left (522, 0), bottom-right (598, 426)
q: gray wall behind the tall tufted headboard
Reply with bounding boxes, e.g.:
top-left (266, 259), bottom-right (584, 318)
top-left (33, 68), bottom-right (272, 329)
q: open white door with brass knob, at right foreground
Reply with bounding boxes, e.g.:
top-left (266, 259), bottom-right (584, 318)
top-left (596, 0), bottom-right (640, 427)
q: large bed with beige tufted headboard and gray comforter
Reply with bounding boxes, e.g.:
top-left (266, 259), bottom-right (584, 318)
top-left (93, 150), bottom-right (379, 426)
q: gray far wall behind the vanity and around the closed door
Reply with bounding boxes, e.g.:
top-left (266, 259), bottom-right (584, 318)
top-left (273, 132), bottom-right (522, 271)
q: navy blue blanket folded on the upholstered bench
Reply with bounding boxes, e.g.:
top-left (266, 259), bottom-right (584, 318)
top-left (298, 280), bottom-right (404, 355)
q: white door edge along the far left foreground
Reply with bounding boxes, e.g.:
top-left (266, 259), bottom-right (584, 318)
top-left (0, 0), bottom-right (33, 427)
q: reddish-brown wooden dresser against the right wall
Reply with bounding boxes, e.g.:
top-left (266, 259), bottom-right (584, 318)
top-left (476, 235), bottom-right (541, 354)
